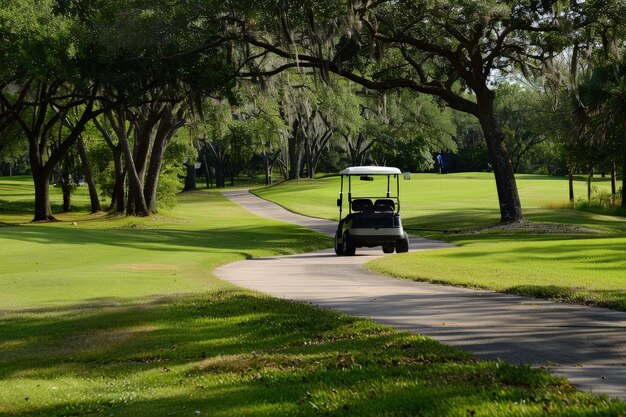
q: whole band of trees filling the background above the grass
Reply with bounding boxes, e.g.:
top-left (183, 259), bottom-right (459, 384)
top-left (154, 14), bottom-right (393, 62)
top-left (0, 0), bottom-right (626, 222)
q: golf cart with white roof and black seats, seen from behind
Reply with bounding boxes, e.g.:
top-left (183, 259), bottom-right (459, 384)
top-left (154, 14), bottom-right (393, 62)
top-left (335, 166), bottom-right (409, 256)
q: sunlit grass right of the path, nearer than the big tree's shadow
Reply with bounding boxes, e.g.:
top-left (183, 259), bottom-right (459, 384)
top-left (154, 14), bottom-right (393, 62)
top-left (368, 236), bottom-right (626, 311)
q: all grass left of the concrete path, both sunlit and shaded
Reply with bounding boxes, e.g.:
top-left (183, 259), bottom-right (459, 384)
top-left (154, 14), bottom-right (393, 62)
top-left (0, 175), bottom-right (626, 416)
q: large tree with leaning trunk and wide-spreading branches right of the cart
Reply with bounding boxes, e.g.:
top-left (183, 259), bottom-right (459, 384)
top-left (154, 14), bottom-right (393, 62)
top-left (230, 0), bottom-right (606, 223)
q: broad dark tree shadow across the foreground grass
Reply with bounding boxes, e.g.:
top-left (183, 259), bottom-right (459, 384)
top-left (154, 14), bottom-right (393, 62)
top-left (0, 290), bottom-right (626, 416)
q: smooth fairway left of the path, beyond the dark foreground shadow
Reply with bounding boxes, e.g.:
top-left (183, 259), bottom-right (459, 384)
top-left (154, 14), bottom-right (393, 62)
top-left (0, 177), bottom-right (329, 309)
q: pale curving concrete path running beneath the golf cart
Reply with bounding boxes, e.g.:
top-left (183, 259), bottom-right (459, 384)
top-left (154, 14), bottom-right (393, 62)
top-left (214, 191), bottom-right (626, 400)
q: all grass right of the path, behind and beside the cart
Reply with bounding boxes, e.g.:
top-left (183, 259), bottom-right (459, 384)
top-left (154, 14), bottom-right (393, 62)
top-left (251, 173), bottom-right (626, 310)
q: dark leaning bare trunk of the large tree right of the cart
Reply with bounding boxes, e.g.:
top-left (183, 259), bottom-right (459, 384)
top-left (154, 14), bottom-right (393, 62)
top-left (477, 89), bottom-right (524, 223)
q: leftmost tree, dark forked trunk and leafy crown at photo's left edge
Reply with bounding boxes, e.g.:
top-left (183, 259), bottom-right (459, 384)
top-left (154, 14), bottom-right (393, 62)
top-left (0, 1), bottom-right (105, 221)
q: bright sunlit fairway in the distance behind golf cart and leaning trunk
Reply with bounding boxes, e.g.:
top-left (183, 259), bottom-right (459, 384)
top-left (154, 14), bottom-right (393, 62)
top-left (254, 173), bottom-right (626, 230)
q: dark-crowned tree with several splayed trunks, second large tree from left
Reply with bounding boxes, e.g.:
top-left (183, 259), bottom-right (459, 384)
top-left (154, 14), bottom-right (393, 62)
top-left (69, 0), bottom-right (233, 216)
